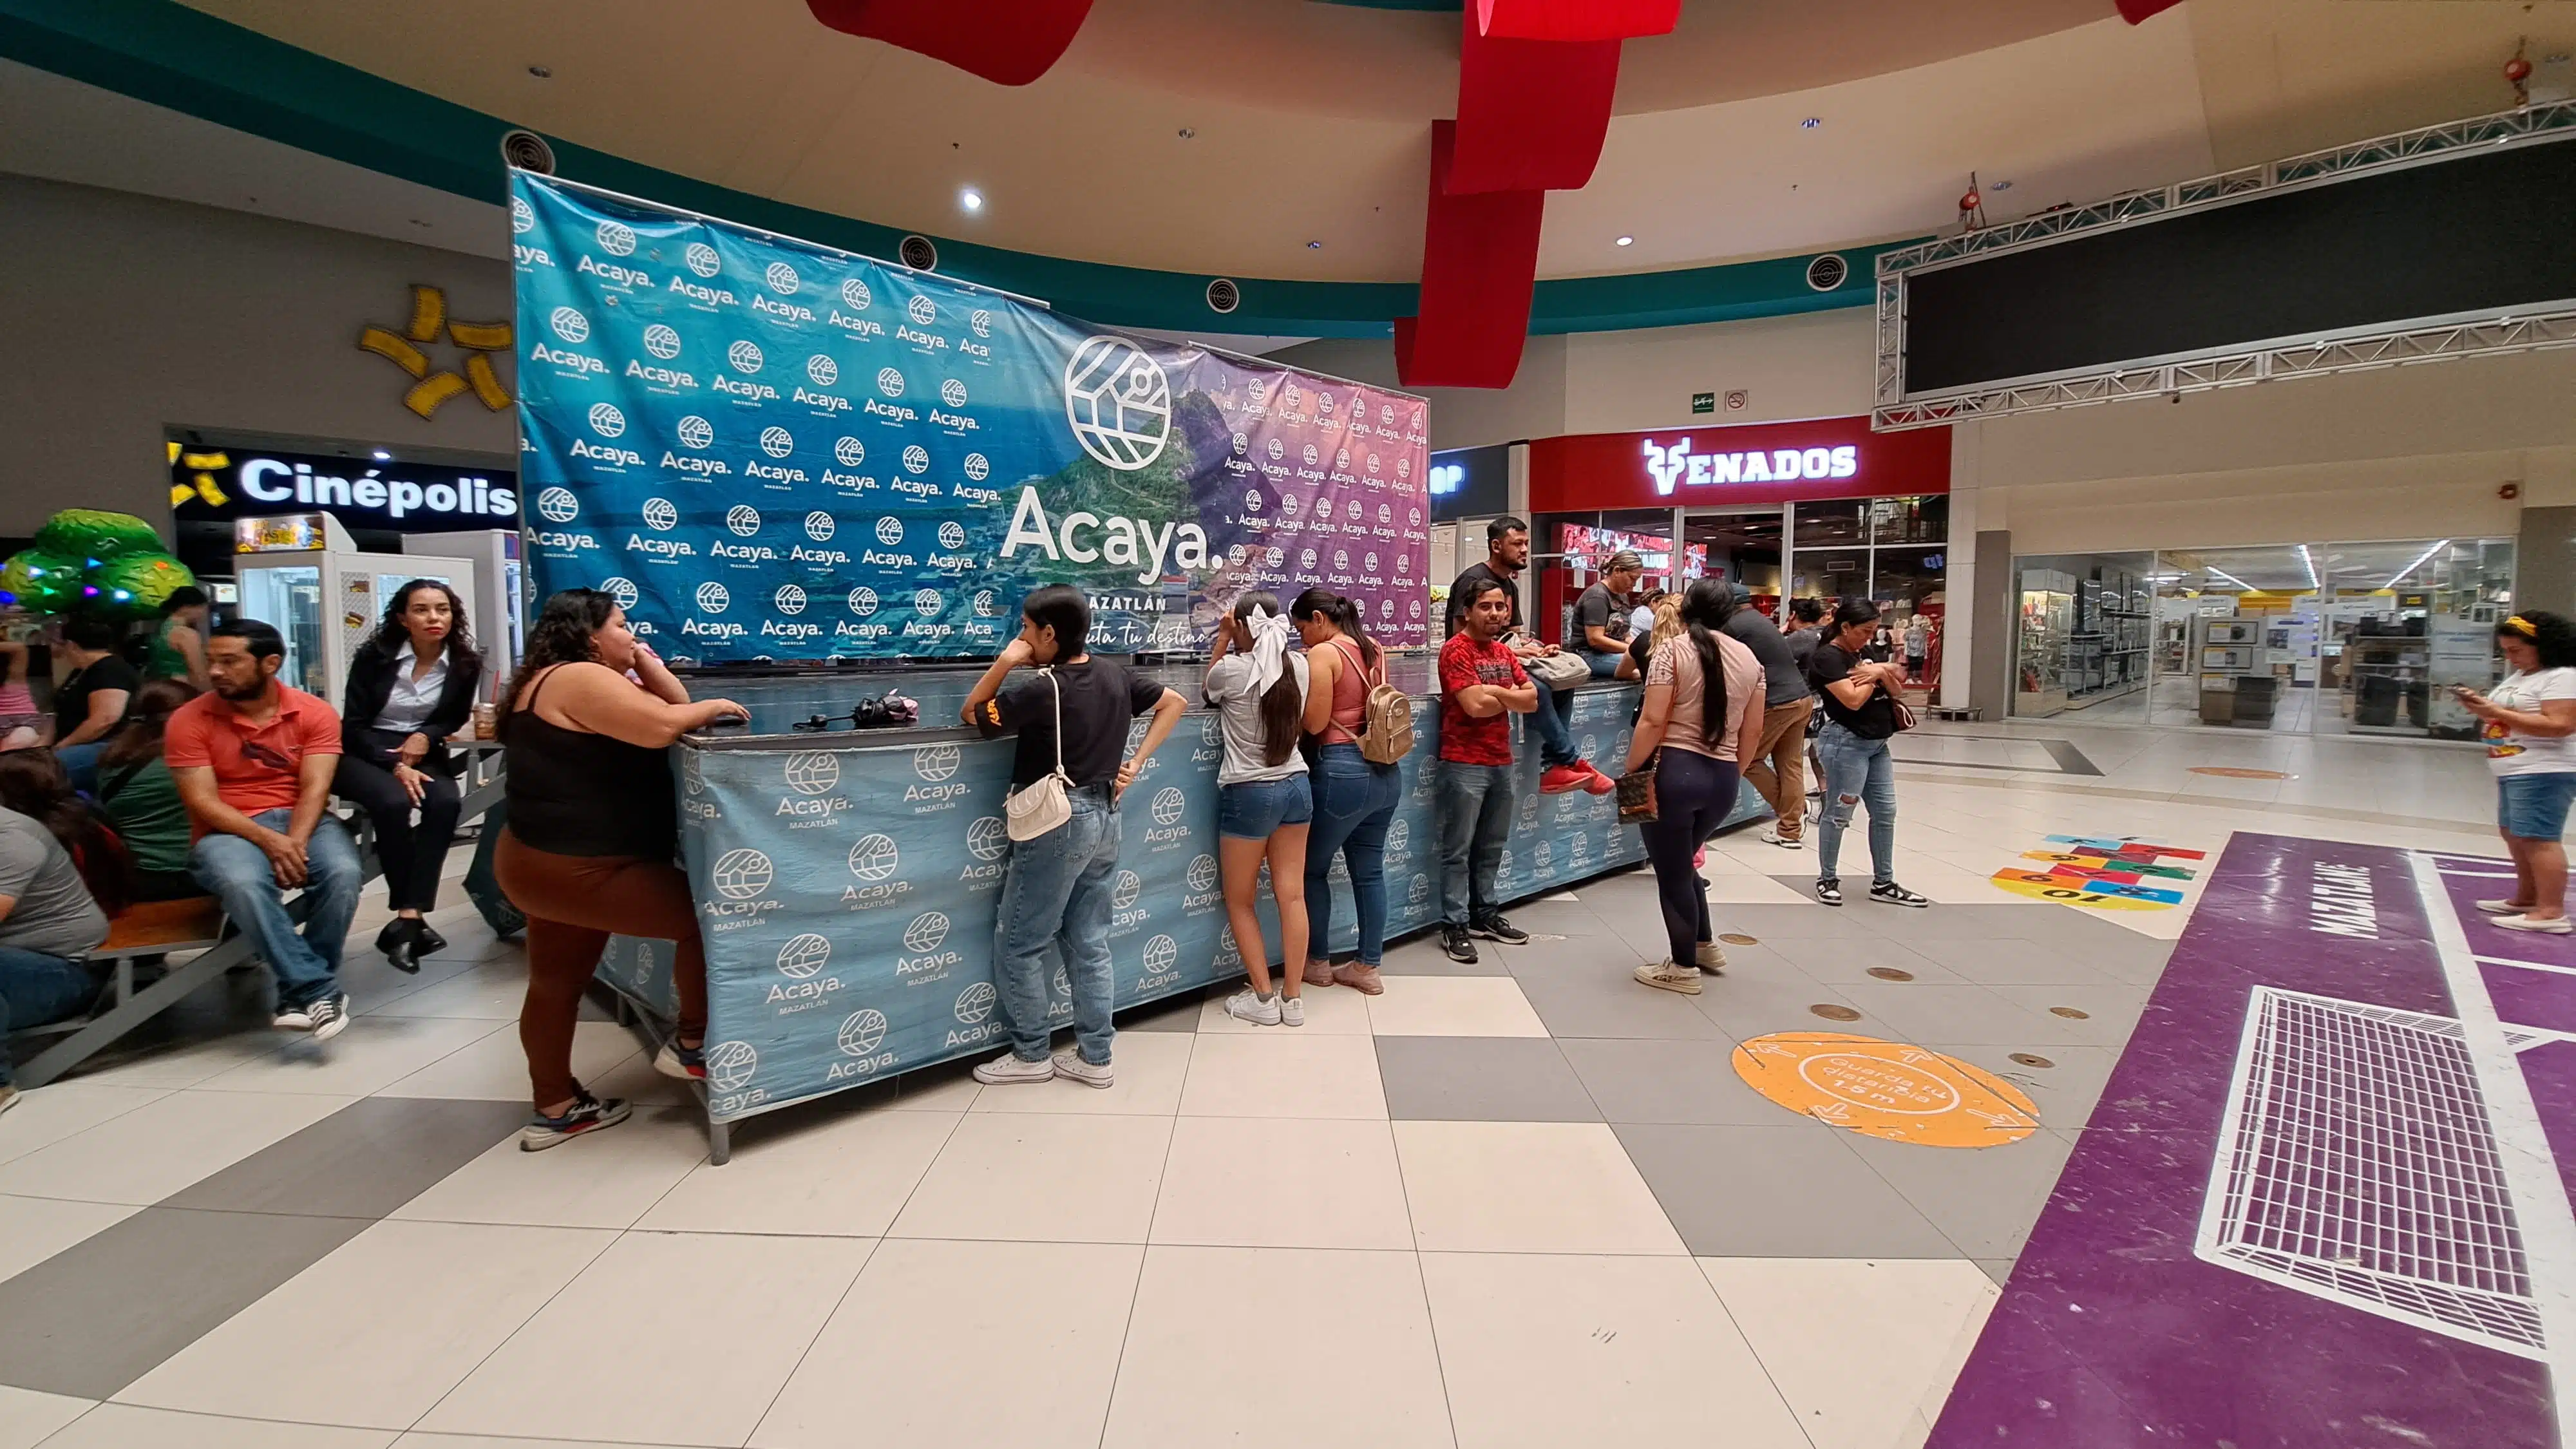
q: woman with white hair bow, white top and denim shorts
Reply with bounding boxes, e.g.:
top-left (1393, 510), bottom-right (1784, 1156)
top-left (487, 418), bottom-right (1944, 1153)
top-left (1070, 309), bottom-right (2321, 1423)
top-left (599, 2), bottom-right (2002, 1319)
top-left (1206, 593), bottom-right (1314, 1026)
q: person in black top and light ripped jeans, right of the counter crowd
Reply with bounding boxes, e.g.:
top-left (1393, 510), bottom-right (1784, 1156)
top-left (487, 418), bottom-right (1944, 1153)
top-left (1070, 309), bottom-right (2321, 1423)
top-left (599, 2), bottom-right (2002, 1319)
top-left (1806, 598), bottom-right (1932, 905)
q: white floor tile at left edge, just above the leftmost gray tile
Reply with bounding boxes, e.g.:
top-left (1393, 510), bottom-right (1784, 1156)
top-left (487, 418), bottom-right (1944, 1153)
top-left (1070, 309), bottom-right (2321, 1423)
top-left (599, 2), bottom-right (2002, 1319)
top-left (0, 1091), bottom-right (355, 1207)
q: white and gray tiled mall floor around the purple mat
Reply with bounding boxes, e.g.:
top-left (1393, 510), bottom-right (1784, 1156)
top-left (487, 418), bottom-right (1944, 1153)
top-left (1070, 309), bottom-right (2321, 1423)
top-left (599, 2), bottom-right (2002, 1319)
top-left (0, 722), bottom-right (2491, 1449)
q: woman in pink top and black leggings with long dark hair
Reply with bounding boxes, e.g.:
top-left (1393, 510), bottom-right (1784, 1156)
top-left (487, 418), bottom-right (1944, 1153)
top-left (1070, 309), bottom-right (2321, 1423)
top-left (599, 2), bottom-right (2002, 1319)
top-left (1628, 578), bottom-right (1762, 995)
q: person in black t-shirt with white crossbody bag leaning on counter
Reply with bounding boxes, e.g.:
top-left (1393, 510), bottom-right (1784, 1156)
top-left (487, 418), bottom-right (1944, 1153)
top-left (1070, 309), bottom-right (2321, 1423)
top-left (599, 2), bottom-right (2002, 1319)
top-left (961, 583), bottom-right (1188, 1088)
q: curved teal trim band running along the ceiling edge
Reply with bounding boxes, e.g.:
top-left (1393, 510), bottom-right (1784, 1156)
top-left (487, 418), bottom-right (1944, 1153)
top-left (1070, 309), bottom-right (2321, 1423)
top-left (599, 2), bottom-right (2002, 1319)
top-left (0, 0), bottom-right (1911, 340)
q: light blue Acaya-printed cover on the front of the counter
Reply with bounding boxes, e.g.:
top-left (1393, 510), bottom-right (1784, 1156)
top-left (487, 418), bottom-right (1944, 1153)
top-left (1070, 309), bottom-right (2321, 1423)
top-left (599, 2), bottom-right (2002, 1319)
top-left (600, 688), bottom-right (1765, 1119)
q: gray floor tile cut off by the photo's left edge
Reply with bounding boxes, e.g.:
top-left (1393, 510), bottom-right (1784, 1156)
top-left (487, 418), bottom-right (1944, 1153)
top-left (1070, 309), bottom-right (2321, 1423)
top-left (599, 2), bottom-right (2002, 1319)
top-left (0, 1206), bottom-right (368, 1397)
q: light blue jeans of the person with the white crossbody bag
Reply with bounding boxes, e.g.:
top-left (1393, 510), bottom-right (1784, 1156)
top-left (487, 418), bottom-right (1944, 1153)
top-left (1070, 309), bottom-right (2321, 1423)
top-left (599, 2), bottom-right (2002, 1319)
top-left (992, 784), bottom-right (1118, 1067)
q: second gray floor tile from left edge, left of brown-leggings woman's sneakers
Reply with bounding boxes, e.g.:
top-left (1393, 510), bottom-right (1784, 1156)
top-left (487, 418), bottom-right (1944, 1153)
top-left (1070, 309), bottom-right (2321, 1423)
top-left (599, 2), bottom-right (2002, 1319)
top-left (162, 1096), bottom-right (528, 1220)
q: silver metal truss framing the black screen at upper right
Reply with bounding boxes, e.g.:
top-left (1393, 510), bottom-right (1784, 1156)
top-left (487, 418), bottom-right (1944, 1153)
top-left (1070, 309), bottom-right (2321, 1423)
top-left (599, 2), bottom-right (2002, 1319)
top-left (1870, 100), bottom-right (2576, 431)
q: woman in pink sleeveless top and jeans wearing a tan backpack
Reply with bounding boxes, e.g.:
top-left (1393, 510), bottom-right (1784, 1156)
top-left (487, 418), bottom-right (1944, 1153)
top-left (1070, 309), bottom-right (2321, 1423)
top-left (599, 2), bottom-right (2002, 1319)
top-left (1288, 588), bottom-right (1404, 995)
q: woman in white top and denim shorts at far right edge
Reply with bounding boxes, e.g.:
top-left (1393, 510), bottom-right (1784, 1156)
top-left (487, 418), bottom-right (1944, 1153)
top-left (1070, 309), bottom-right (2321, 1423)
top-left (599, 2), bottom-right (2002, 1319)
top-left (2452, 609), bottom-right (2576, 936)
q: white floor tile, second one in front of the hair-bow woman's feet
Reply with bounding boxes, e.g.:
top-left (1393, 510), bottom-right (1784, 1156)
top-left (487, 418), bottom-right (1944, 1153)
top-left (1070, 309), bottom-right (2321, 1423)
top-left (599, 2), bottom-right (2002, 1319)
top-left (1154, 1117), bottom-right (1414, 1248)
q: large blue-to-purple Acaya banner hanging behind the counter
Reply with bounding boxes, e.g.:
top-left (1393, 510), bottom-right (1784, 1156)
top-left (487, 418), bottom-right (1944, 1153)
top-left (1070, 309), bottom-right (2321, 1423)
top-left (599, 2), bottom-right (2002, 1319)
top-left (510, 173), bottom-right (1430, 663)
